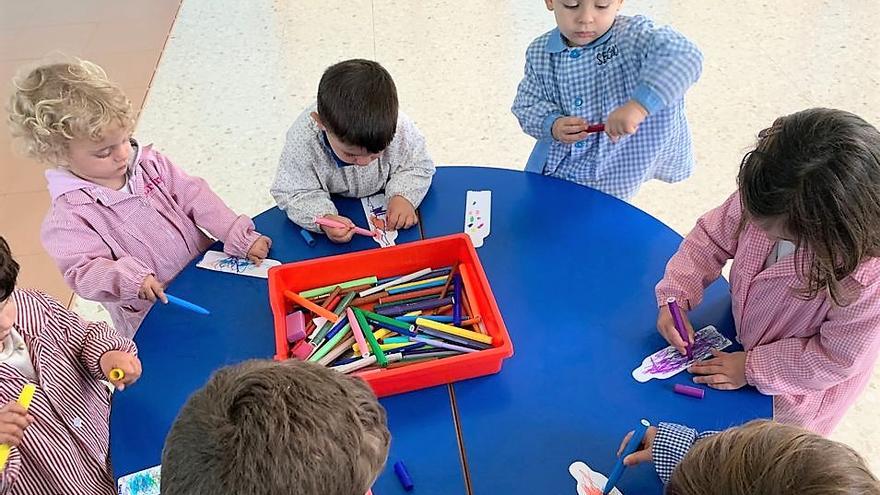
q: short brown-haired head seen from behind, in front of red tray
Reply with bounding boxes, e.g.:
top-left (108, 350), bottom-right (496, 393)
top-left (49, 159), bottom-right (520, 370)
top-left (161, 360), bottom-right (390, 495)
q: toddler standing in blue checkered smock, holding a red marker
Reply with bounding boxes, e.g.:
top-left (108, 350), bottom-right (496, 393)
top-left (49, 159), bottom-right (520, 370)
top-left (511, 0), bottom-right (703, 200)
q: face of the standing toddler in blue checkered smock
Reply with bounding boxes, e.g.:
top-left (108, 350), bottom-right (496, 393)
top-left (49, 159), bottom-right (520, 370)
top-left (544, 0), bottom-right (623, 46)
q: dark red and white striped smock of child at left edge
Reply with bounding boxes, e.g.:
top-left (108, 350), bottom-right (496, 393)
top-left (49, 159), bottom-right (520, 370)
top-left (0, 290), bottom-right (137, 495)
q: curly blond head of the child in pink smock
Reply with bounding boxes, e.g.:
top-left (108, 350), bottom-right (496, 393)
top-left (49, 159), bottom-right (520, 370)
top-left (8, 60), bottom-right (134, 187)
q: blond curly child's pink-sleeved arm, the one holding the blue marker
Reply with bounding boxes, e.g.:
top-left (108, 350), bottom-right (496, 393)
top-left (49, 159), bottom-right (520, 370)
top-left (40, 220), bottom-right (155, 301)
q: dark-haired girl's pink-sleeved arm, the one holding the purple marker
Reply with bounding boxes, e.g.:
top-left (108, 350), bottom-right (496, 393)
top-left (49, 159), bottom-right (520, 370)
top-left (655, 193), bottom-right (742, 310)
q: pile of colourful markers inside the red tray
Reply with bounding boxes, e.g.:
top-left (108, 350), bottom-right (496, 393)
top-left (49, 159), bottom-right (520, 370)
top-left (284, 264), bottom-right (492, 373)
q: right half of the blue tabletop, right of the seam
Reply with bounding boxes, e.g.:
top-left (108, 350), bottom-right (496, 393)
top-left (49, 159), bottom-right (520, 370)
top-left (420, 167), bottom-right (772, 494)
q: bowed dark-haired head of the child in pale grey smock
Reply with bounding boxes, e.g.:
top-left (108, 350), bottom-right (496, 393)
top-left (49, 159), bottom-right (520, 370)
top-left (312, 59), bottom-right (398, 165)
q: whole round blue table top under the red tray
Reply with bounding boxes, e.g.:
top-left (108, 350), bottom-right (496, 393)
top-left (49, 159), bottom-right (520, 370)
top-left (110, 167), bottom-right (772, 495)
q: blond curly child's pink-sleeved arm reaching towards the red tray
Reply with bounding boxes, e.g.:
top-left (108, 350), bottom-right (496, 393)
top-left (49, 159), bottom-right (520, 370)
top-left (147, 150), bottom-right (261, 258)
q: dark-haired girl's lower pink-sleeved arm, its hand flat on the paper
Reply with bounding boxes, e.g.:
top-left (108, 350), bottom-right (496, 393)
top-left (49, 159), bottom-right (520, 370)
top-left (746, 282), bottom-right (880, 395)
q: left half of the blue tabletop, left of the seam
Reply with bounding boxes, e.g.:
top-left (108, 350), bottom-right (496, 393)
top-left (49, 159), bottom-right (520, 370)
top-left (110, 198), bottom-right (466, 495)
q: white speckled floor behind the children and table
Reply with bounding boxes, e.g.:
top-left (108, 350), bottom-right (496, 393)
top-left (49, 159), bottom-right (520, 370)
top-left (75, 0), bottom-right (880, 473)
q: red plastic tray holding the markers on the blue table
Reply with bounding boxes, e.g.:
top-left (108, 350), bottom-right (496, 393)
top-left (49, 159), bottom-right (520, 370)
top-left (269, 234), bottom-right (513, 397)
